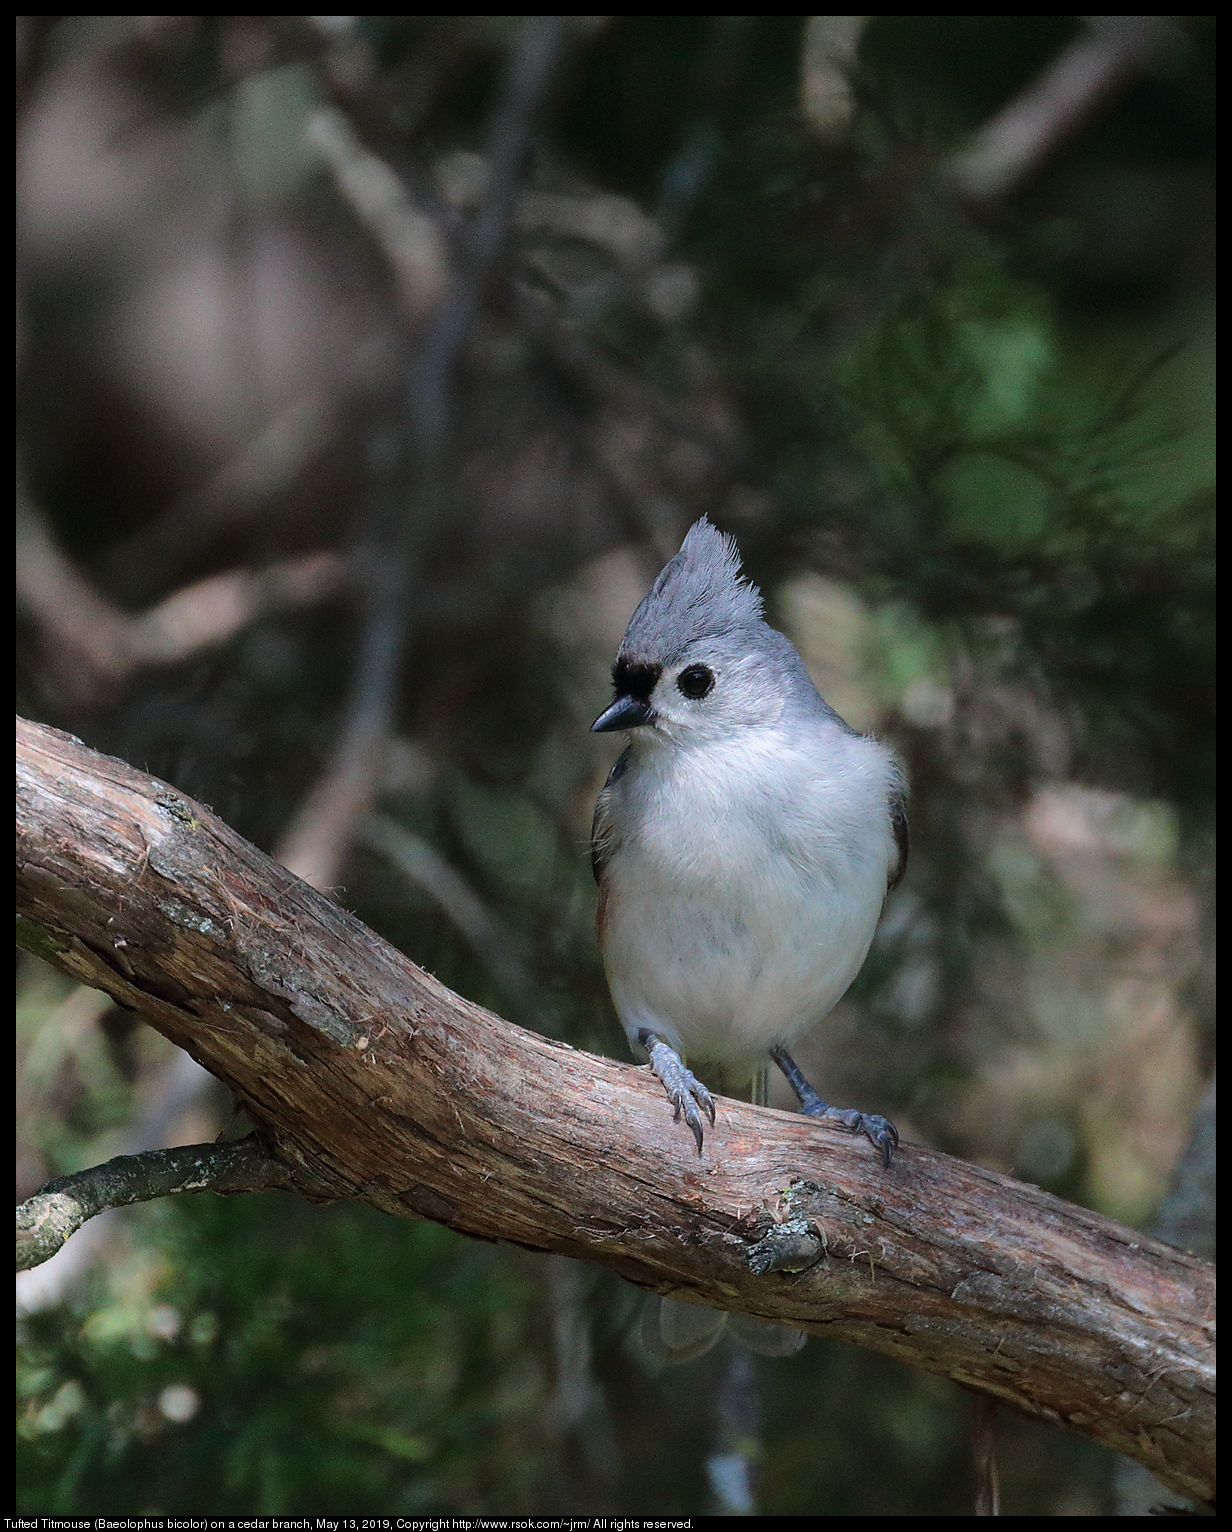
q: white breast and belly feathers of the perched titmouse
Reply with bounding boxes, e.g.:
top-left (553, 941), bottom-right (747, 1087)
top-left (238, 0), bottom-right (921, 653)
top-left (601, 726), bottom-right (896, 1072)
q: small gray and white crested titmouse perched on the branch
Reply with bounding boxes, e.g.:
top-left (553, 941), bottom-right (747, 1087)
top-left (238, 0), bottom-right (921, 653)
top-left (591, 518), bottom-right (907, 1164)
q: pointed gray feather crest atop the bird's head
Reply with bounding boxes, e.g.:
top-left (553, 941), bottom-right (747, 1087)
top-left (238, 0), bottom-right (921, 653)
top-left (621, 516), bottom-right (763, 663)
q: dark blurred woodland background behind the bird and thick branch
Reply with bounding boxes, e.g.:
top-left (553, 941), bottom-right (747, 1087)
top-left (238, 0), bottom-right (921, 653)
top-left (17, 17), bottom-right (1214, 1515)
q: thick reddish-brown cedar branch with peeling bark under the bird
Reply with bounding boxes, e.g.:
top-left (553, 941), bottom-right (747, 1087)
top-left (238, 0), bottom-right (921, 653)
top-left (17, 720), bottom-right (1215, 1501)
